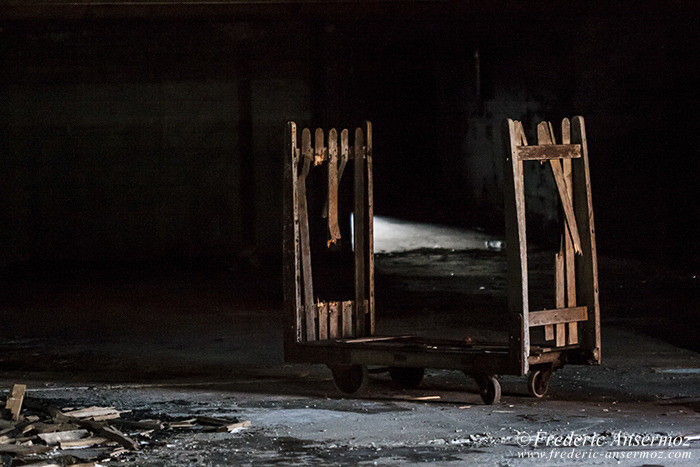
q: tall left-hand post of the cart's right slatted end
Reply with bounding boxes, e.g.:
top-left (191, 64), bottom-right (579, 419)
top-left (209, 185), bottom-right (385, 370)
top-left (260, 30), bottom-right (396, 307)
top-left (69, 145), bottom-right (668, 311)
top-left (503, 119), bottom-right (530, 374)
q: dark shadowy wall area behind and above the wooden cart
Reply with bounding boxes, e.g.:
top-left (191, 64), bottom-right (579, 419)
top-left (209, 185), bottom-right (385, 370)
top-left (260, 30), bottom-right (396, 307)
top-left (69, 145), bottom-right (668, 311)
top-left (0, 1), bottom-right (700, 280)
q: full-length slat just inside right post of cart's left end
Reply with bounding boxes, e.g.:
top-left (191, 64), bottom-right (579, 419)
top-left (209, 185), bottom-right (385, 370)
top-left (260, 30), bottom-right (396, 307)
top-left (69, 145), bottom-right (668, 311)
top-left (353, 128), bottom-right (367, 337)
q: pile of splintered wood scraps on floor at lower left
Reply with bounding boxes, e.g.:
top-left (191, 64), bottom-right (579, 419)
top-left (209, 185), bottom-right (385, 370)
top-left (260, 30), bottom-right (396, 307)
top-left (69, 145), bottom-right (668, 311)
top-left (0, 384), bottom-right (251, 467)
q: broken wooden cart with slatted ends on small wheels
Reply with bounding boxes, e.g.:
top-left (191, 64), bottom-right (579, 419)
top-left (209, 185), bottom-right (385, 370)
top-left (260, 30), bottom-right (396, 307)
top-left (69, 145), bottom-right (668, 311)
top-left (284, 117), bottom-right (601, 404)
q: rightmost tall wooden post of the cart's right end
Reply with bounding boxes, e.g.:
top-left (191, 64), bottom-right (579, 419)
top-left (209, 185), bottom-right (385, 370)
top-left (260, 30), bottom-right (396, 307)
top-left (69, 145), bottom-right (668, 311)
top-left (571, 116), bottom-right (601, 363)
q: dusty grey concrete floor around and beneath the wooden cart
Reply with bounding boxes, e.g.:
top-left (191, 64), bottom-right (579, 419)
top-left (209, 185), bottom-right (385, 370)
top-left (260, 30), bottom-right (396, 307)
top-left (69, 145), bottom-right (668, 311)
top-left (0, 221), bottom-right (700, 466)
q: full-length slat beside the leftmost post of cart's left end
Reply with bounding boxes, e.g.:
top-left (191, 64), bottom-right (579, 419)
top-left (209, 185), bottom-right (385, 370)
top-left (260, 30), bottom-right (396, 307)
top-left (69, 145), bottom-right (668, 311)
top-left (298, 128), bottom-right (316, 341)
